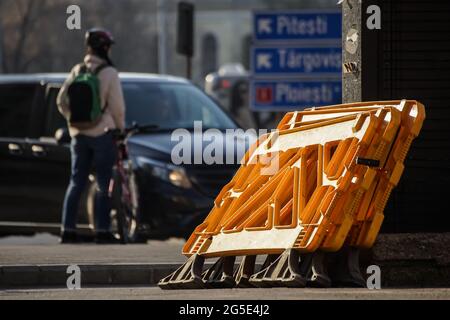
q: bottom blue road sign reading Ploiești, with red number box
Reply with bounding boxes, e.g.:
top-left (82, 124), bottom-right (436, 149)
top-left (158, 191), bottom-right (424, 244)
top-left (250, 79), bottom-right (342, 111)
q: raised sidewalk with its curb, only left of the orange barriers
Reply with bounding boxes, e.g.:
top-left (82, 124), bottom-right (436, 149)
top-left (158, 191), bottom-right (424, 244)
top-left (0, 239), bottom-right (185, 288)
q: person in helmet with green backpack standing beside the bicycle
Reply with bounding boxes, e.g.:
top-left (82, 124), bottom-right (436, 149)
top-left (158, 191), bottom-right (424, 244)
top-left (57, 28), bottom-right (125, 243)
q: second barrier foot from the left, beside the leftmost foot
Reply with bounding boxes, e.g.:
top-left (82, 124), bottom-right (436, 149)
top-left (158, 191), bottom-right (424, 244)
top-left (202, 256), bottom-right (236, 288)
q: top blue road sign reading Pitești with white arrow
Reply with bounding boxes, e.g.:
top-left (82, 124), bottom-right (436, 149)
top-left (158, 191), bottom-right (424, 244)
top-left (253, 11), bottom-right (342, 41)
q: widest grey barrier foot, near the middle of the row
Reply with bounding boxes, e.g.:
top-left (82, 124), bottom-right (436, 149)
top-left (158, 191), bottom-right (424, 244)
top-left (250, 249), bottom-right (306, 288)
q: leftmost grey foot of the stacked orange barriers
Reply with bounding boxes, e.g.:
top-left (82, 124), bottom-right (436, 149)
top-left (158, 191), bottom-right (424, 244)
top-left (158, 254), bottom-right (205, 289)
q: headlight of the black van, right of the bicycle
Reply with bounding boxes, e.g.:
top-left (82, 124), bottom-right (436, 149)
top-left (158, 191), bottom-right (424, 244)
top-left (136, 156), bottom-right (192, 189)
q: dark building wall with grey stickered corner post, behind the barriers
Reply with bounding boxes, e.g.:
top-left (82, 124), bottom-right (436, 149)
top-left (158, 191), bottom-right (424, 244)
top-left (343, 0), bottom-right (450, 232)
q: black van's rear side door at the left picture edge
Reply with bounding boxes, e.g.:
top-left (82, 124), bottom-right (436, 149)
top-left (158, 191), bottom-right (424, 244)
top-left (0, 83), bottom-right (40, 224)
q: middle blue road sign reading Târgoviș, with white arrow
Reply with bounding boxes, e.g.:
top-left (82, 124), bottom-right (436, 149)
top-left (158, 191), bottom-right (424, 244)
top-left (251, 46), bottom-right (342, 77)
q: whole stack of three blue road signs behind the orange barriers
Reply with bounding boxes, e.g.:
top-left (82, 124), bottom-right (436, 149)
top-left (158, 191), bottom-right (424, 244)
top-left (250, 10), bottom-right (342, 111)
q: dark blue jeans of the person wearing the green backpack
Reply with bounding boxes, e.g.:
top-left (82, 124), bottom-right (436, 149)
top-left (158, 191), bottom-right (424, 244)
top-left (62, 133), bottom-right (116, 232)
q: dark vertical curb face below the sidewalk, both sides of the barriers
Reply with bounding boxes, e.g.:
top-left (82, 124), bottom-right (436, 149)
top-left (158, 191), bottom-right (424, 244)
top-left (0, 259), bottom-right (450, 289)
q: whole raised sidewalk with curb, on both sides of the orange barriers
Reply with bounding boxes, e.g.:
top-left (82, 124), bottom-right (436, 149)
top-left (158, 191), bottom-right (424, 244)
top-left (0, 233), bottom-right (450, 288)
